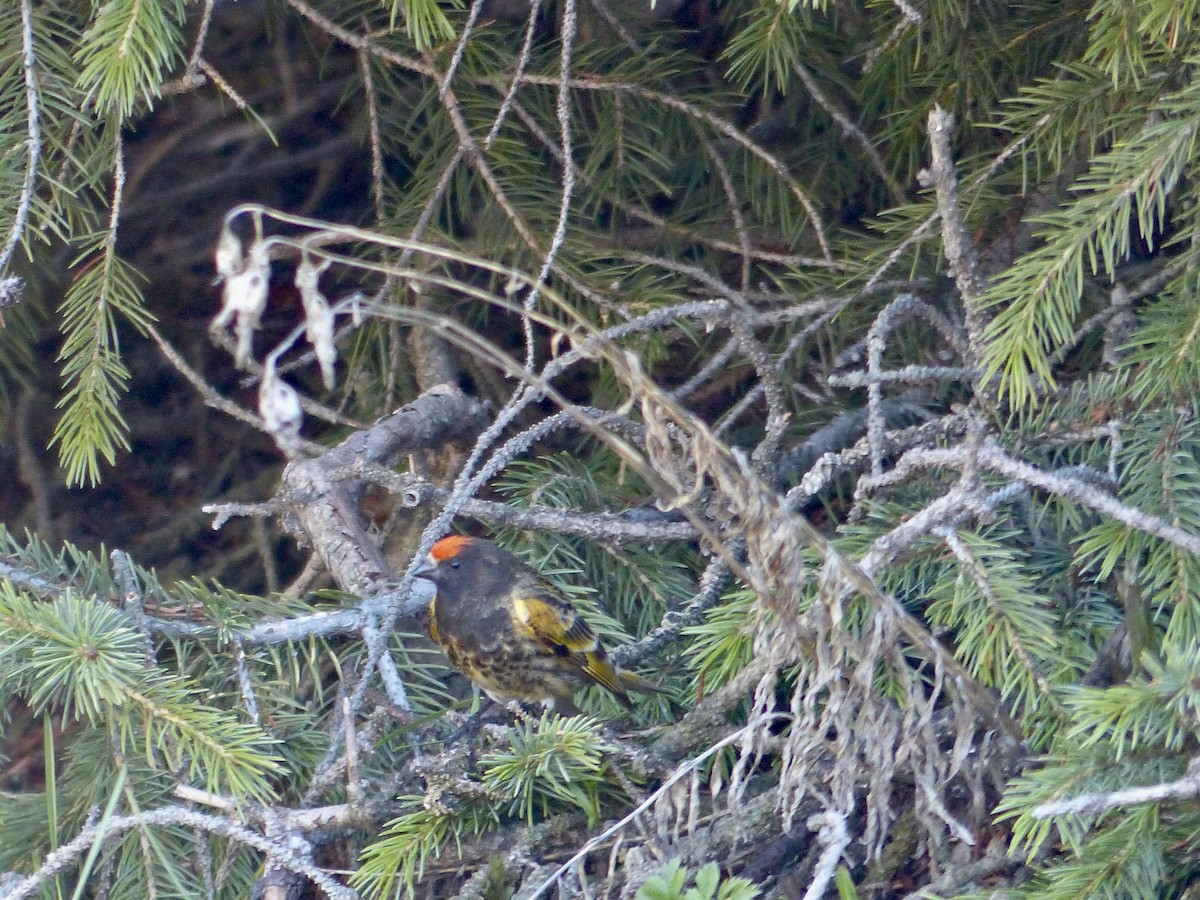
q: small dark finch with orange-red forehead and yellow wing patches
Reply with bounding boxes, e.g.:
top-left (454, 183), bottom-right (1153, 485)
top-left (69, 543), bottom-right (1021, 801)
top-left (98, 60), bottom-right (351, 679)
top-left (415, 534), bottom-right (666, 715)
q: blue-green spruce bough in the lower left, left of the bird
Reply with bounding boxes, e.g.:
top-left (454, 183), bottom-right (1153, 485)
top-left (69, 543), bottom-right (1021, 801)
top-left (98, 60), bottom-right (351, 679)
top-left (0, 528), bottom-right (348, 898)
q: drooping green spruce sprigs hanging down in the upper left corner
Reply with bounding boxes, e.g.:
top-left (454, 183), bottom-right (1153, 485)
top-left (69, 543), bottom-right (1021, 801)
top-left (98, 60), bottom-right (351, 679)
top-left (0, 0), bottom-right (152, 485)
